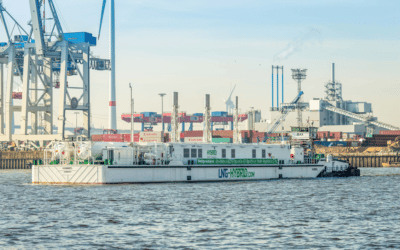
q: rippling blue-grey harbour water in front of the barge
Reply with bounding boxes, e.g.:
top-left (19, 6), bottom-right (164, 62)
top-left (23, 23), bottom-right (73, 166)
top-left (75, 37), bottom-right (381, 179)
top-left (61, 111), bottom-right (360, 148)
top-left (0, 168), bottom-right (400, 249)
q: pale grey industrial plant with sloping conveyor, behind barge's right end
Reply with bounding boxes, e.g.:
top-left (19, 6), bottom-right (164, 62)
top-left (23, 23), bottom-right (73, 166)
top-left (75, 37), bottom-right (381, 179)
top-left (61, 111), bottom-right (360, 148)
top-left (266, 64), bottom-right (398, 136)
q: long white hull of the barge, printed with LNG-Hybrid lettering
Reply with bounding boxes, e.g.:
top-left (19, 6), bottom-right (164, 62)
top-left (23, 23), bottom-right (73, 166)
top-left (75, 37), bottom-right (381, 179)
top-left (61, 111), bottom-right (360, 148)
top-left (32, 165), bottom-right (325, 184)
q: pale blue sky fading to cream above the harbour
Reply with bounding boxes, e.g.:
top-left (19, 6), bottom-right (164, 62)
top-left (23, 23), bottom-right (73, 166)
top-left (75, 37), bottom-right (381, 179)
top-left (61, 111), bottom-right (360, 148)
top-left (0, 0), bottom-right (400, 129)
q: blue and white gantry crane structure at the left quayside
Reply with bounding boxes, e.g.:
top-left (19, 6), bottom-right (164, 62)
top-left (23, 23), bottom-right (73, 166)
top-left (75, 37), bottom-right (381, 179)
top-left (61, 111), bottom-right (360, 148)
top-left (0, 0), bottom-right (111, 144)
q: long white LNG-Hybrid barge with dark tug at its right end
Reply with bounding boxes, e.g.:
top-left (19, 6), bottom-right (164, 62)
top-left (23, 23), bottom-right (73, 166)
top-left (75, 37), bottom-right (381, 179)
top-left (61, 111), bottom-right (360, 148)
top-left (32, 141), bottom-right (360, 184)
